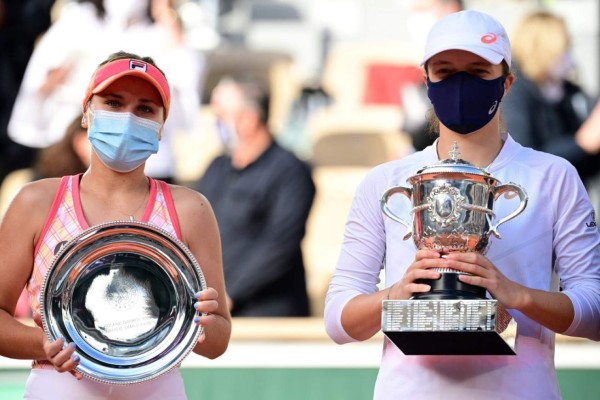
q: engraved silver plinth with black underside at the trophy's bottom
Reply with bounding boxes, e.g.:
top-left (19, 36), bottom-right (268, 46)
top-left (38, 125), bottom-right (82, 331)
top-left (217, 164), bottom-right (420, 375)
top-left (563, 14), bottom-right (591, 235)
top-left (381, 299), bottom-right (516, 355)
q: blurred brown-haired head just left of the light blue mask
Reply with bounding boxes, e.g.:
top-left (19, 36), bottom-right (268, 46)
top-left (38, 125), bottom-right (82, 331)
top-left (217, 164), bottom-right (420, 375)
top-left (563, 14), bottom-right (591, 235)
top-left (34, 115), bottom-right (91, 179)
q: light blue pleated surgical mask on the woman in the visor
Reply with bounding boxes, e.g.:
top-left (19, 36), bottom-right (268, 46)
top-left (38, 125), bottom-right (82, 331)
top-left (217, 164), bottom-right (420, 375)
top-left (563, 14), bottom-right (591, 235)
top-left (88, 110), bottom-right (162, 172)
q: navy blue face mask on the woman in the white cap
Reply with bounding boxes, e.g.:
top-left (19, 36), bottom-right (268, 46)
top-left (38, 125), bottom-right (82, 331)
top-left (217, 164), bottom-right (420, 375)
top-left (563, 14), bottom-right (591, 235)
top-left (427, 71), bottom-right (506, 135)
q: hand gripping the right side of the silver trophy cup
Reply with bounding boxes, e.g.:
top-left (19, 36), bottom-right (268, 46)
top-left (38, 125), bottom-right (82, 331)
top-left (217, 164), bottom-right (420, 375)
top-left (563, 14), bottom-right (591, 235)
top-left (442, 252), bottom-right (523, 308)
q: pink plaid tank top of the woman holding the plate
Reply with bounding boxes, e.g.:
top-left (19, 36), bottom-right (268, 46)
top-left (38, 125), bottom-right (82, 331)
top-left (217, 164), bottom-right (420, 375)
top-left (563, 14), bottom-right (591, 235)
top-left (27, 174), bottom-right (181, 313)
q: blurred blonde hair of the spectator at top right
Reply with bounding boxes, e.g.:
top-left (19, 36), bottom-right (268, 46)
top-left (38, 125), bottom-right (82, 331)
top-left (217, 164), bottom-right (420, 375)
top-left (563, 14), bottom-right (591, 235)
top-left (511, 11), bottom-right (569, 83)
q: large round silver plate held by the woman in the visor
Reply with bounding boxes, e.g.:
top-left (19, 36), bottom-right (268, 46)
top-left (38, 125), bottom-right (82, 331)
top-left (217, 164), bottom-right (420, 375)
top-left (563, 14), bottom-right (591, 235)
top-left (40, 221), bottom-right (206, 384)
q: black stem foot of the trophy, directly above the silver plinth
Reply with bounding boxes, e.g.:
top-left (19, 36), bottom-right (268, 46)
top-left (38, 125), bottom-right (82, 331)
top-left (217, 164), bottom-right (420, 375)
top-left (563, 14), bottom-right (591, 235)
top-left (412, 272), bottom-right (486, 300)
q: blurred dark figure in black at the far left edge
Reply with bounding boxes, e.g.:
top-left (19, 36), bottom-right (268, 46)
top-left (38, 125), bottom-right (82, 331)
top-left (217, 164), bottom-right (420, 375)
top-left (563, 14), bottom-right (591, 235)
top-left (0, 0), bottom-right (54, 188)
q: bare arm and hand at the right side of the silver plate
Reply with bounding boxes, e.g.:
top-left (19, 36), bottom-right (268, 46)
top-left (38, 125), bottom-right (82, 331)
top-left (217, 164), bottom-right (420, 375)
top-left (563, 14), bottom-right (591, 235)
top-left (171, 186), bottom-right (231, 358)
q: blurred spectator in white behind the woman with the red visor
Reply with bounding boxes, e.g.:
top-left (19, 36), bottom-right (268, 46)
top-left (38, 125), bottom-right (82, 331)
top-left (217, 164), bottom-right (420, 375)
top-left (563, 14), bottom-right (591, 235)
top-left (8, 0), bottom-right (204, 181)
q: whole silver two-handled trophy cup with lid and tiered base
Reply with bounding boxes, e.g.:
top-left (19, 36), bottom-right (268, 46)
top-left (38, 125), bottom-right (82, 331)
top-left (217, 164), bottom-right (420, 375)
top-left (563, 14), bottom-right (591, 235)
top-left (381, 142), bottom-right (527, 354)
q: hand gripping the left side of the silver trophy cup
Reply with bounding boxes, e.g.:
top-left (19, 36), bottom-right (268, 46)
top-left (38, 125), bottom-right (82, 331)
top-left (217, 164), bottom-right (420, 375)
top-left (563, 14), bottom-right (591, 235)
top-left (388, 249), bottom-right (441, 300)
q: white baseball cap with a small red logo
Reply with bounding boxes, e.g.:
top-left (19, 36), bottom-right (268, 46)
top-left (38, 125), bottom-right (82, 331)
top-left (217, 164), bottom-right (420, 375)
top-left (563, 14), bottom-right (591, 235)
top-left (421, 10), bottom-right (511, 66)
